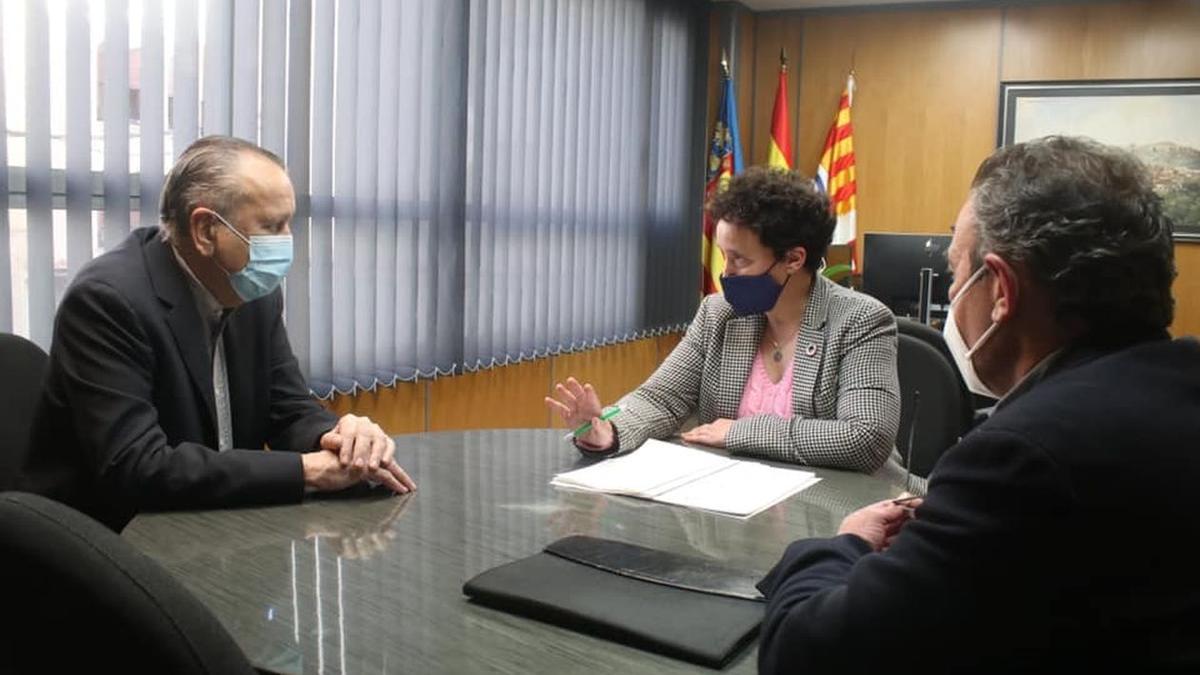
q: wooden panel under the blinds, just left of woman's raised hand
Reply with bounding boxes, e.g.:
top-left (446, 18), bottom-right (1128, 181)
top-left (427, 359), bottom-right (550, 431)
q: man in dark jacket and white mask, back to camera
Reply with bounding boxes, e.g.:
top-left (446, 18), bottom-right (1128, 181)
top-left (760, 137), bottom-right (1200, 674)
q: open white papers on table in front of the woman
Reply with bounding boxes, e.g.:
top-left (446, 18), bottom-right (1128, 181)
top-left (550, 440), bottom-right (820, 518)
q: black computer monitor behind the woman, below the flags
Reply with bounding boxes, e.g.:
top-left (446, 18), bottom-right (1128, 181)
top-left (863, 232), bottom-right (950, 318)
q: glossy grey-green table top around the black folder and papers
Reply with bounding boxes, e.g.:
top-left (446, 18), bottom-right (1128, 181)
top-left (124, 430), bottom-right (899, 673)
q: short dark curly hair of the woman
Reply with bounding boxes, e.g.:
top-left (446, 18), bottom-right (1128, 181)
top-left (707, 167), bottom-right (838, 270)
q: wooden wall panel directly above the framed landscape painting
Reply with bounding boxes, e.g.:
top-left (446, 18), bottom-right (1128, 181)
top-left (1003, 0), bottom-right (1200, 80)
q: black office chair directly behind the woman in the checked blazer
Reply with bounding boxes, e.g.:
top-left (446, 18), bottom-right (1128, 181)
top-left (896, 331), bottom-right (974, 477)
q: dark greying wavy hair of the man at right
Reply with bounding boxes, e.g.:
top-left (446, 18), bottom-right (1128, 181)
top-left (971, 136), bottom-right (1175, 340)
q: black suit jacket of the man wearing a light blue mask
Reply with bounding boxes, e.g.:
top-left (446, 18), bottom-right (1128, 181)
top-left (23, 228), bottom-right (336, 530)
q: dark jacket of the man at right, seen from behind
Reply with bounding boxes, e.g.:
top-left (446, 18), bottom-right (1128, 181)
top-left (760, 339), bottom-right (1200, 674)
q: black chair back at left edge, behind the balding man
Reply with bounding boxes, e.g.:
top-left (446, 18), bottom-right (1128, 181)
top-left (0, 333), bottom-right (49, 490)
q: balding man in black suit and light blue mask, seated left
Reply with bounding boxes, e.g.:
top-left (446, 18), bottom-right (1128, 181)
top-left (23, 137), bottom-right (415, 531)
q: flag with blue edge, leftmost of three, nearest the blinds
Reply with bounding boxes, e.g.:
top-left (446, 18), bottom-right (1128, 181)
top-left (700, 55), bottom-right (743, 295)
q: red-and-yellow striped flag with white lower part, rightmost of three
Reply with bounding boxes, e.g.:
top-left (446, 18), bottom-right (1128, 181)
top-left (816, 72), bottom-right (859, 269)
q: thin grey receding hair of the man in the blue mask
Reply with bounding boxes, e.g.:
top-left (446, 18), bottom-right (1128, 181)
top-left (158, 136), bottom-right (284, 239)
